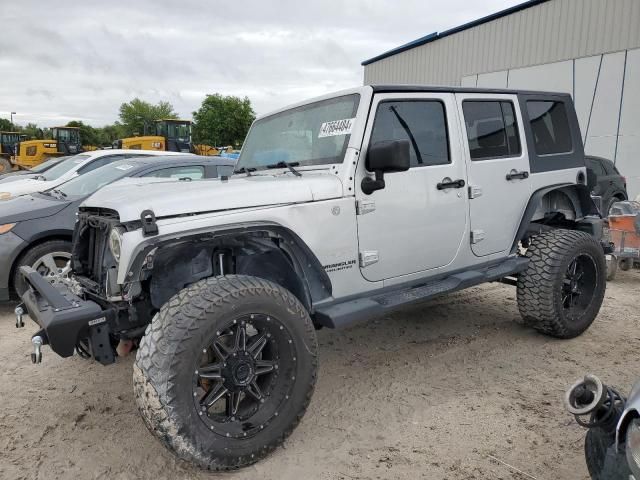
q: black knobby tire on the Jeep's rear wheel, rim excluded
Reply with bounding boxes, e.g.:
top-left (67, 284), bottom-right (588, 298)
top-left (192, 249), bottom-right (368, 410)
top-left (517, 229), bottom-right (607, 338)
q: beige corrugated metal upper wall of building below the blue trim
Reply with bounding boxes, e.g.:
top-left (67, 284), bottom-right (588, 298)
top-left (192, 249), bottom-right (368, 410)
top-left (364, 0), bottom-right (640, 85)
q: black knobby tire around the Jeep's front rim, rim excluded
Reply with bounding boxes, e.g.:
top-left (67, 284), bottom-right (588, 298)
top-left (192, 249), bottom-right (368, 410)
top-left (133, 275), bottom-right (318, 471)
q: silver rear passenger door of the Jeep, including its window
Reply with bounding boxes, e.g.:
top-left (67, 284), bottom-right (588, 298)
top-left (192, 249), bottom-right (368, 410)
top-left (456, 94), bottom-right (531, 257)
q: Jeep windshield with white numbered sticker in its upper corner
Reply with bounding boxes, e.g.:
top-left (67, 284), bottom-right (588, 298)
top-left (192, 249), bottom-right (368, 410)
top-left (236, 94), bottom-right (360, 169)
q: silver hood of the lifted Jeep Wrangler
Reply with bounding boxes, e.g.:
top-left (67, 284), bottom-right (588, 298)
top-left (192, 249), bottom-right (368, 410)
top-left (82, 172), bottom-right (342, 222)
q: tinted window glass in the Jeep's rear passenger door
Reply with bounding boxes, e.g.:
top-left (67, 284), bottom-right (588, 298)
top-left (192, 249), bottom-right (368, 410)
top-left (462, 100), bottom-right (522, 160)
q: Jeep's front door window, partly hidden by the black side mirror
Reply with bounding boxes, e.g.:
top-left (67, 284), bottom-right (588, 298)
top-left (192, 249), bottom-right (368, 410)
top-left (371, 100), bottom-right (451, 167)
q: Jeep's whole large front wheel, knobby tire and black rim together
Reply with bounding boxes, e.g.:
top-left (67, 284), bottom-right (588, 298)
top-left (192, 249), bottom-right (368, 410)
top-left (133, 275), bottom-right (317, 470)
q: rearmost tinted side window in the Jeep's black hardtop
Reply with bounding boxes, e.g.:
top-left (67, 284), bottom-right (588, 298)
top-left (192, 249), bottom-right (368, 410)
top-left (527, 100), bottom-right (572, 155)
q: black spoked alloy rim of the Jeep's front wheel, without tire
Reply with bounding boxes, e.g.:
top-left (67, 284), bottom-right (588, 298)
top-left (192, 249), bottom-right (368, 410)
top-left (193, 313), bottom-right (297, 439)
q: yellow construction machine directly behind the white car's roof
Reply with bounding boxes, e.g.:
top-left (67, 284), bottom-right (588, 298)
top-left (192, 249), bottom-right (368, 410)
top-left (113, 118), bottom-right (225, 156)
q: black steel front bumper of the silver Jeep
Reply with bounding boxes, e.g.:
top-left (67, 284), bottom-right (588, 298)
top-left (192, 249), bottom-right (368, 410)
top-left (20, 267), bottom-right (114, 363)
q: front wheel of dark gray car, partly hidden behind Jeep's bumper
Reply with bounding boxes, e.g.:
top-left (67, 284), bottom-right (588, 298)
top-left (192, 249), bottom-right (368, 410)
top-left (13, 240), bottom-right (71, 295)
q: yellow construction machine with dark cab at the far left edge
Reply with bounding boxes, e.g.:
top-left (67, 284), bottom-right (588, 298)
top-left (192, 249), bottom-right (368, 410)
top-left (0, 127), bottom-right (84, 173)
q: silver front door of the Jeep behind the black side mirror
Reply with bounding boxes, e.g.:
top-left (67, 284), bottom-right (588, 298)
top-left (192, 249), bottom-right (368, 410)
top-left (356, 93), bottom-right (468, 281)
